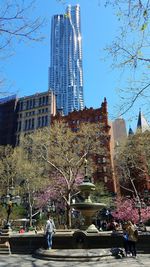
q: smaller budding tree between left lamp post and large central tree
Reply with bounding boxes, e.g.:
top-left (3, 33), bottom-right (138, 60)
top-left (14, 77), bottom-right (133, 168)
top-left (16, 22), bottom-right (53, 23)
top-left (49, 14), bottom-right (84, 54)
top-left (15, 147), bottom-right (45, 226)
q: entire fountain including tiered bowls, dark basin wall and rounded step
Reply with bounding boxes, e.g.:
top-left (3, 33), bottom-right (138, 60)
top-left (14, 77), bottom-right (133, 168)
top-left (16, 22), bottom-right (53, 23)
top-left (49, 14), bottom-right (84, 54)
top-left (8, 160), bottom-right (108, 260)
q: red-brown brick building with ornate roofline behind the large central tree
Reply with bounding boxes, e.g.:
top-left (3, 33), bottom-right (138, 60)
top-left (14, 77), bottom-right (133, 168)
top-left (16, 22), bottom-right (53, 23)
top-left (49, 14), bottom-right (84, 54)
top-left (52, 98), bottom-right (116, 193)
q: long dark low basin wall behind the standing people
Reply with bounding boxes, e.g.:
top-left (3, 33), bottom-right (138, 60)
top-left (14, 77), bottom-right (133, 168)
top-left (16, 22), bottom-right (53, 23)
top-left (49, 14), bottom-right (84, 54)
top-left (9, 231), bottom-right (150, 254)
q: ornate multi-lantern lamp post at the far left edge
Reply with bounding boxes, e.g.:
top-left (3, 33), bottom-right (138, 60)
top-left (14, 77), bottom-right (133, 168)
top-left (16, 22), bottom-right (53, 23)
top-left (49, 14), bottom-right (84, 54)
top-left (0, 183), bottom-right (21, 229)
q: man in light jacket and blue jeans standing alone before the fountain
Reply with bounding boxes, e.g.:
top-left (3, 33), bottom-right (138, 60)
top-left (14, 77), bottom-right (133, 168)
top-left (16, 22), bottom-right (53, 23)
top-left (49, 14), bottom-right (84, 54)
top-left (44, 214), bottom-right (56, 249)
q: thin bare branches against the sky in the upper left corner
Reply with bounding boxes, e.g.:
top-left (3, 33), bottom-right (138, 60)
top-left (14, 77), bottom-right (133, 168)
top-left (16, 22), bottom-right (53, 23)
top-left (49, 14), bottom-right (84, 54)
top-left (0, 0), bottom-right (44, 94)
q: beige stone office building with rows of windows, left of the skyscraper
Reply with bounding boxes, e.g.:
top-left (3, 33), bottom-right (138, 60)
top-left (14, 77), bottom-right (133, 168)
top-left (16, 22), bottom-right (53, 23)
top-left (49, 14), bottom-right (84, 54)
top-left (16, 90), bottom-right (56, 143)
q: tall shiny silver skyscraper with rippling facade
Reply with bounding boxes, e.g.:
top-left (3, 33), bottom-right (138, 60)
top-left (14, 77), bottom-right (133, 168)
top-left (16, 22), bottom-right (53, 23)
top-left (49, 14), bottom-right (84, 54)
top-left (49, 5), bottom-right (84, 115)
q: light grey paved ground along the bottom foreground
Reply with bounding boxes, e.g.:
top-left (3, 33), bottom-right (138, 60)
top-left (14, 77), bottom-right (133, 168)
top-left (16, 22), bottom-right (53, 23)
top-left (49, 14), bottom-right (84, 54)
top-left (0, 254), bottom-right (150, 267)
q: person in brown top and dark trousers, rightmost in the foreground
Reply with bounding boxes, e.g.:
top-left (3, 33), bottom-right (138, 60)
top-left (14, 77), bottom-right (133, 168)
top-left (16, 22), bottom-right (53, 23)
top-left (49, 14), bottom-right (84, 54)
top-left (126, 221), bottom-right (138, 258)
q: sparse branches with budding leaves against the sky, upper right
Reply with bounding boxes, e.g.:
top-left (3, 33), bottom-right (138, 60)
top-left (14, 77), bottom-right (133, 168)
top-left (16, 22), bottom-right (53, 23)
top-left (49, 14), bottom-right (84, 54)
top-left (105, 0), bottom-right (150, 115)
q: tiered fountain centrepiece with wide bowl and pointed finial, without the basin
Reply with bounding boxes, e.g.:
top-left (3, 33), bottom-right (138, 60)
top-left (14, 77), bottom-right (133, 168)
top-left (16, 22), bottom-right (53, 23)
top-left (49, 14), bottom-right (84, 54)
top-left (71, 159), bottom-right (106, 232)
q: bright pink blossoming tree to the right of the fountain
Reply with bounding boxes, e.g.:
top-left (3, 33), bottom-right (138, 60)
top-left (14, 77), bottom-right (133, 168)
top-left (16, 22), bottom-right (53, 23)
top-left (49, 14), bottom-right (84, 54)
top-left (112, 198), bottom-right (150, 223)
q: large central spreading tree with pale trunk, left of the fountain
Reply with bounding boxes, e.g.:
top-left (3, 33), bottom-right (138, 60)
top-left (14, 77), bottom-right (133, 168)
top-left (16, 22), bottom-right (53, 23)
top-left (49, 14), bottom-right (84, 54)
top-left (21, 122), bottom-right (108, 227)
